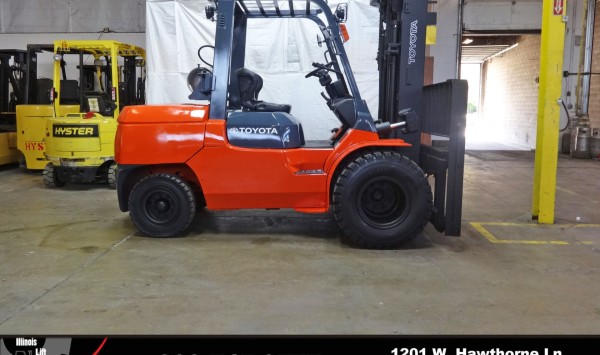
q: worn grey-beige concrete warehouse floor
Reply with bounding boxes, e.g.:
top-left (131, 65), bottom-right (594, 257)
top-left (0, 151), bottom-right (600, 335)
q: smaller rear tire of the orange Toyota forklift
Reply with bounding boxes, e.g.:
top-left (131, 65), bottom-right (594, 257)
top-left (129, 174), bottom-right (196, 238)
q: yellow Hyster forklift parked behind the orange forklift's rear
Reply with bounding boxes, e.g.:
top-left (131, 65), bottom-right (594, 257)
top-left (43, 40), bottom-right (146, 188)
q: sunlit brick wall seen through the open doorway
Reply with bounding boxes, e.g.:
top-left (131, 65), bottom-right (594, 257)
top-left (482, 35), bottom-right (540, 149)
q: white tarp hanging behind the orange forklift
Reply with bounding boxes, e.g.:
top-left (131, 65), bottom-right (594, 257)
top-left (146, 0), bottom-right (379, 140)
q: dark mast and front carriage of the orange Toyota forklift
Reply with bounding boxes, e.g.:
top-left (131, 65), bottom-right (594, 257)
top-left (371, 0), bottom-right (468, 236)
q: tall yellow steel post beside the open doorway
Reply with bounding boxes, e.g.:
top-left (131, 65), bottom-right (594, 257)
top-left (532, 0), bottom-right (567, 224)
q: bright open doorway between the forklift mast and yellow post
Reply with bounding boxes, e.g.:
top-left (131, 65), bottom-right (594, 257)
top-left (461, 34), bottom-right (540, 150)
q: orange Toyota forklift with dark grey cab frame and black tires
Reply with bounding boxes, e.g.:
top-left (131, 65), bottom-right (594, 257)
top-left (115, 0), bottom-right (466, 249)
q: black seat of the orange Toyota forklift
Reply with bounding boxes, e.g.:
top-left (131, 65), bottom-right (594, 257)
top-left (236, 68), bottom-right (292, 113)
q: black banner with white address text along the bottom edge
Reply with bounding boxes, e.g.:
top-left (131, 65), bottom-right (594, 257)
top-left (0, 336), bottom-right (600, 355)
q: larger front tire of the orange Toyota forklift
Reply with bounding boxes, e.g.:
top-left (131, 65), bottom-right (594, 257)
top-left (332, 151), bottom-right (433, 249)
